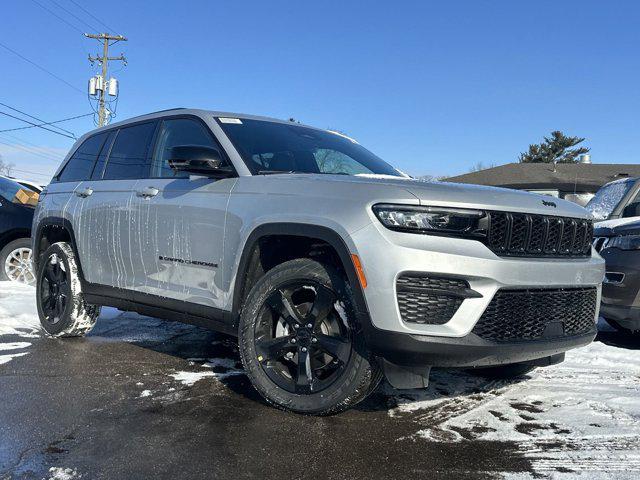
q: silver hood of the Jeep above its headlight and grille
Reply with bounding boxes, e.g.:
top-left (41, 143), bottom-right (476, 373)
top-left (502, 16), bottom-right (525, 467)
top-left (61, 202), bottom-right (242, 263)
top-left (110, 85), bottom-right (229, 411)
top-left (302, 174), bottom-right (590, 218)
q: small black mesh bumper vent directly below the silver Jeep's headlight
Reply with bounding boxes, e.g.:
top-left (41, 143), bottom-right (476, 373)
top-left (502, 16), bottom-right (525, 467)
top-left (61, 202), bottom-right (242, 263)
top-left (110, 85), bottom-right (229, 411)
top-left (396, 274), bottom-right (469, 325)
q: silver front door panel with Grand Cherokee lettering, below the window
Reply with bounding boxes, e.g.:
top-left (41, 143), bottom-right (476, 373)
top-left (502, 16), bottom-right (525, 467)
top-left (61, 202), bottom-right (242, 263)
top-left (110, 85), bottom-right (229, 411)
top-left (134, 178), bottom-right (236, 307)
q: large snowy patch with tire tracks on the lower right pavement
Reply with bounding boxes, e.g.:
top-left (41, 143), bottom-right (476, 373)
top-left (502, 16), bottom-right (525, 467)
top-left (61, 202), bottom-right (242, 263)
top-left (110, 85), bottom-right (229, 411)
top-left (389, 343), bottom-right (640, 478)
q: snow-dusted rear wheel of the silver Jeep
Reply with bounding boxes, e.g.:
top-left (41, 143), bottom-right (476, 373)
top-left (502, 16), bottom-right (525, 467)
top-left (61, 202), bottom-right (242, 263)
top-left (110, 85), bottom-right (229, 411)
top-left (36, 242), bottom-right (100, 337)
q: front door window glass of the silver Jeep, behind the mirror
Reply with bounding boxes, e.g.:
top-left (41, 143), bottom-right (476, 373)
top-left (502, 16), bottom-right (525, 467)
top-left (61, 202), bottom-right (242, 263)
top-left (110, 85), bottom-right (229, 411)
top-left (151, 118), bottom-right (217, 178)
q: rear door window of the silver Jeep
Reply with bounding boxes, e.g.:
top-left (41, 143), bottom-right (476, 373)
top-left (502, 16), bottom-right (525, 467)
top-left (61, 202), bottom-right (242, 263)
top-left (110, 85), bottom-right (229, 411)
top-left (102, 122), bottom-right (156, 180)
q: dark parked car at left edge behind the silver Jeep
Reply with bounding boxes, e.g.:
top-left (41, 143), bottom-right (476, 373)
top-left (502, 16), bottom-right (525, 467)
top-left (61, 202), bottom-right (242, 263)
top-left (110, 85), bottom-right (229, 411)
top-left (0, 177), bottom-right (35, 284)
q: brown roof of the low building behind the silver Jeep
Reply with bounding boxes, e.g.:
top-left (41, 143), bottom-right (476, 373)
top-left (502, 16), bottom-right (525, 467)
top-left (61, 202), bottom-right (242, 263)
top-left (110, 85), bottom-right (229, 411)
top-left (445, 163), bottom-right (640, 192)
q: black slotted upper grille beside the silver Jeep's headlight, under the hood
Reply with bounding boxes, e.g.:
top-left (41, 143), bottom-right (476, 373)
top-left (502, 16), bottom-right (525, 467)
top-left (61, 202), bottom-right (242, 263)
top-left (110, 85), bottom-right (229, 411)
top-left (487, 212), bottom-right (593, 257)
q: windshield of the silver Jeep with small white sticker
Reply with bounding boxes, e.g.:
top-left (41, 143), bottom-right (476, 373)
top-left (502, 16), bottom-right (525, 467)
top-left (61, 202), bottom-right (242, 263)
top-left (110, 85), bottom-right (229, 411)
top-left (218, 118), bottom-right (403, 177)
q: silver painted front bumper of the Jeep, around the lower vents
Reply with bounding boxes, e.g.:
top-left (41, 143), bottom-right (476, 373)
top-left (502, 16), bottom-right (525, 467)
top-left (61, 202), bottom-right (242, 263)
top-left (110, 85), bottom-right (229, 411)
top-left (351, 222), bottom-right (604, 338)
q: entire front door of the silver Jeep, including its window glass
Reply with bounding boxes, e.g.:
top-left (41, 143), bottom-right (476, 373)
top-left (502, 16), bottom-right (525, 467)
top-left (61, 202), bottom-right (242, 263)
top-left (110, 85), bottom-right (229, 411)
top-left (135, 117), bottom-right (236, 307)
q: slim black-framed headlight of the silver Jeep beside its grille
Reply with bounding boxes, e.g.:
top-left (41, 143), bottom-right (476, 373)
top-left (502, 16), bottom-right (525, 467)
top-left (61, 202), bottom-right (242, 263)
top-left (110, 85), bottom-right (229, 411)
top-left (373, 204), bottom-right (487, 237)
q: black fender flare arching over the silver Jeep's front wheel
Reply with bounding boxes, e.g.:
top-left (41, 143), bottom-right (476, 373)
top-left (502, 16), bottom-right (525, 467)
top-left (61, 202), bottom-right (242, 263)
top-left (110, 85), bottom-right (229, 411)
top-left (232, 222), bottom-right (370, 323)
